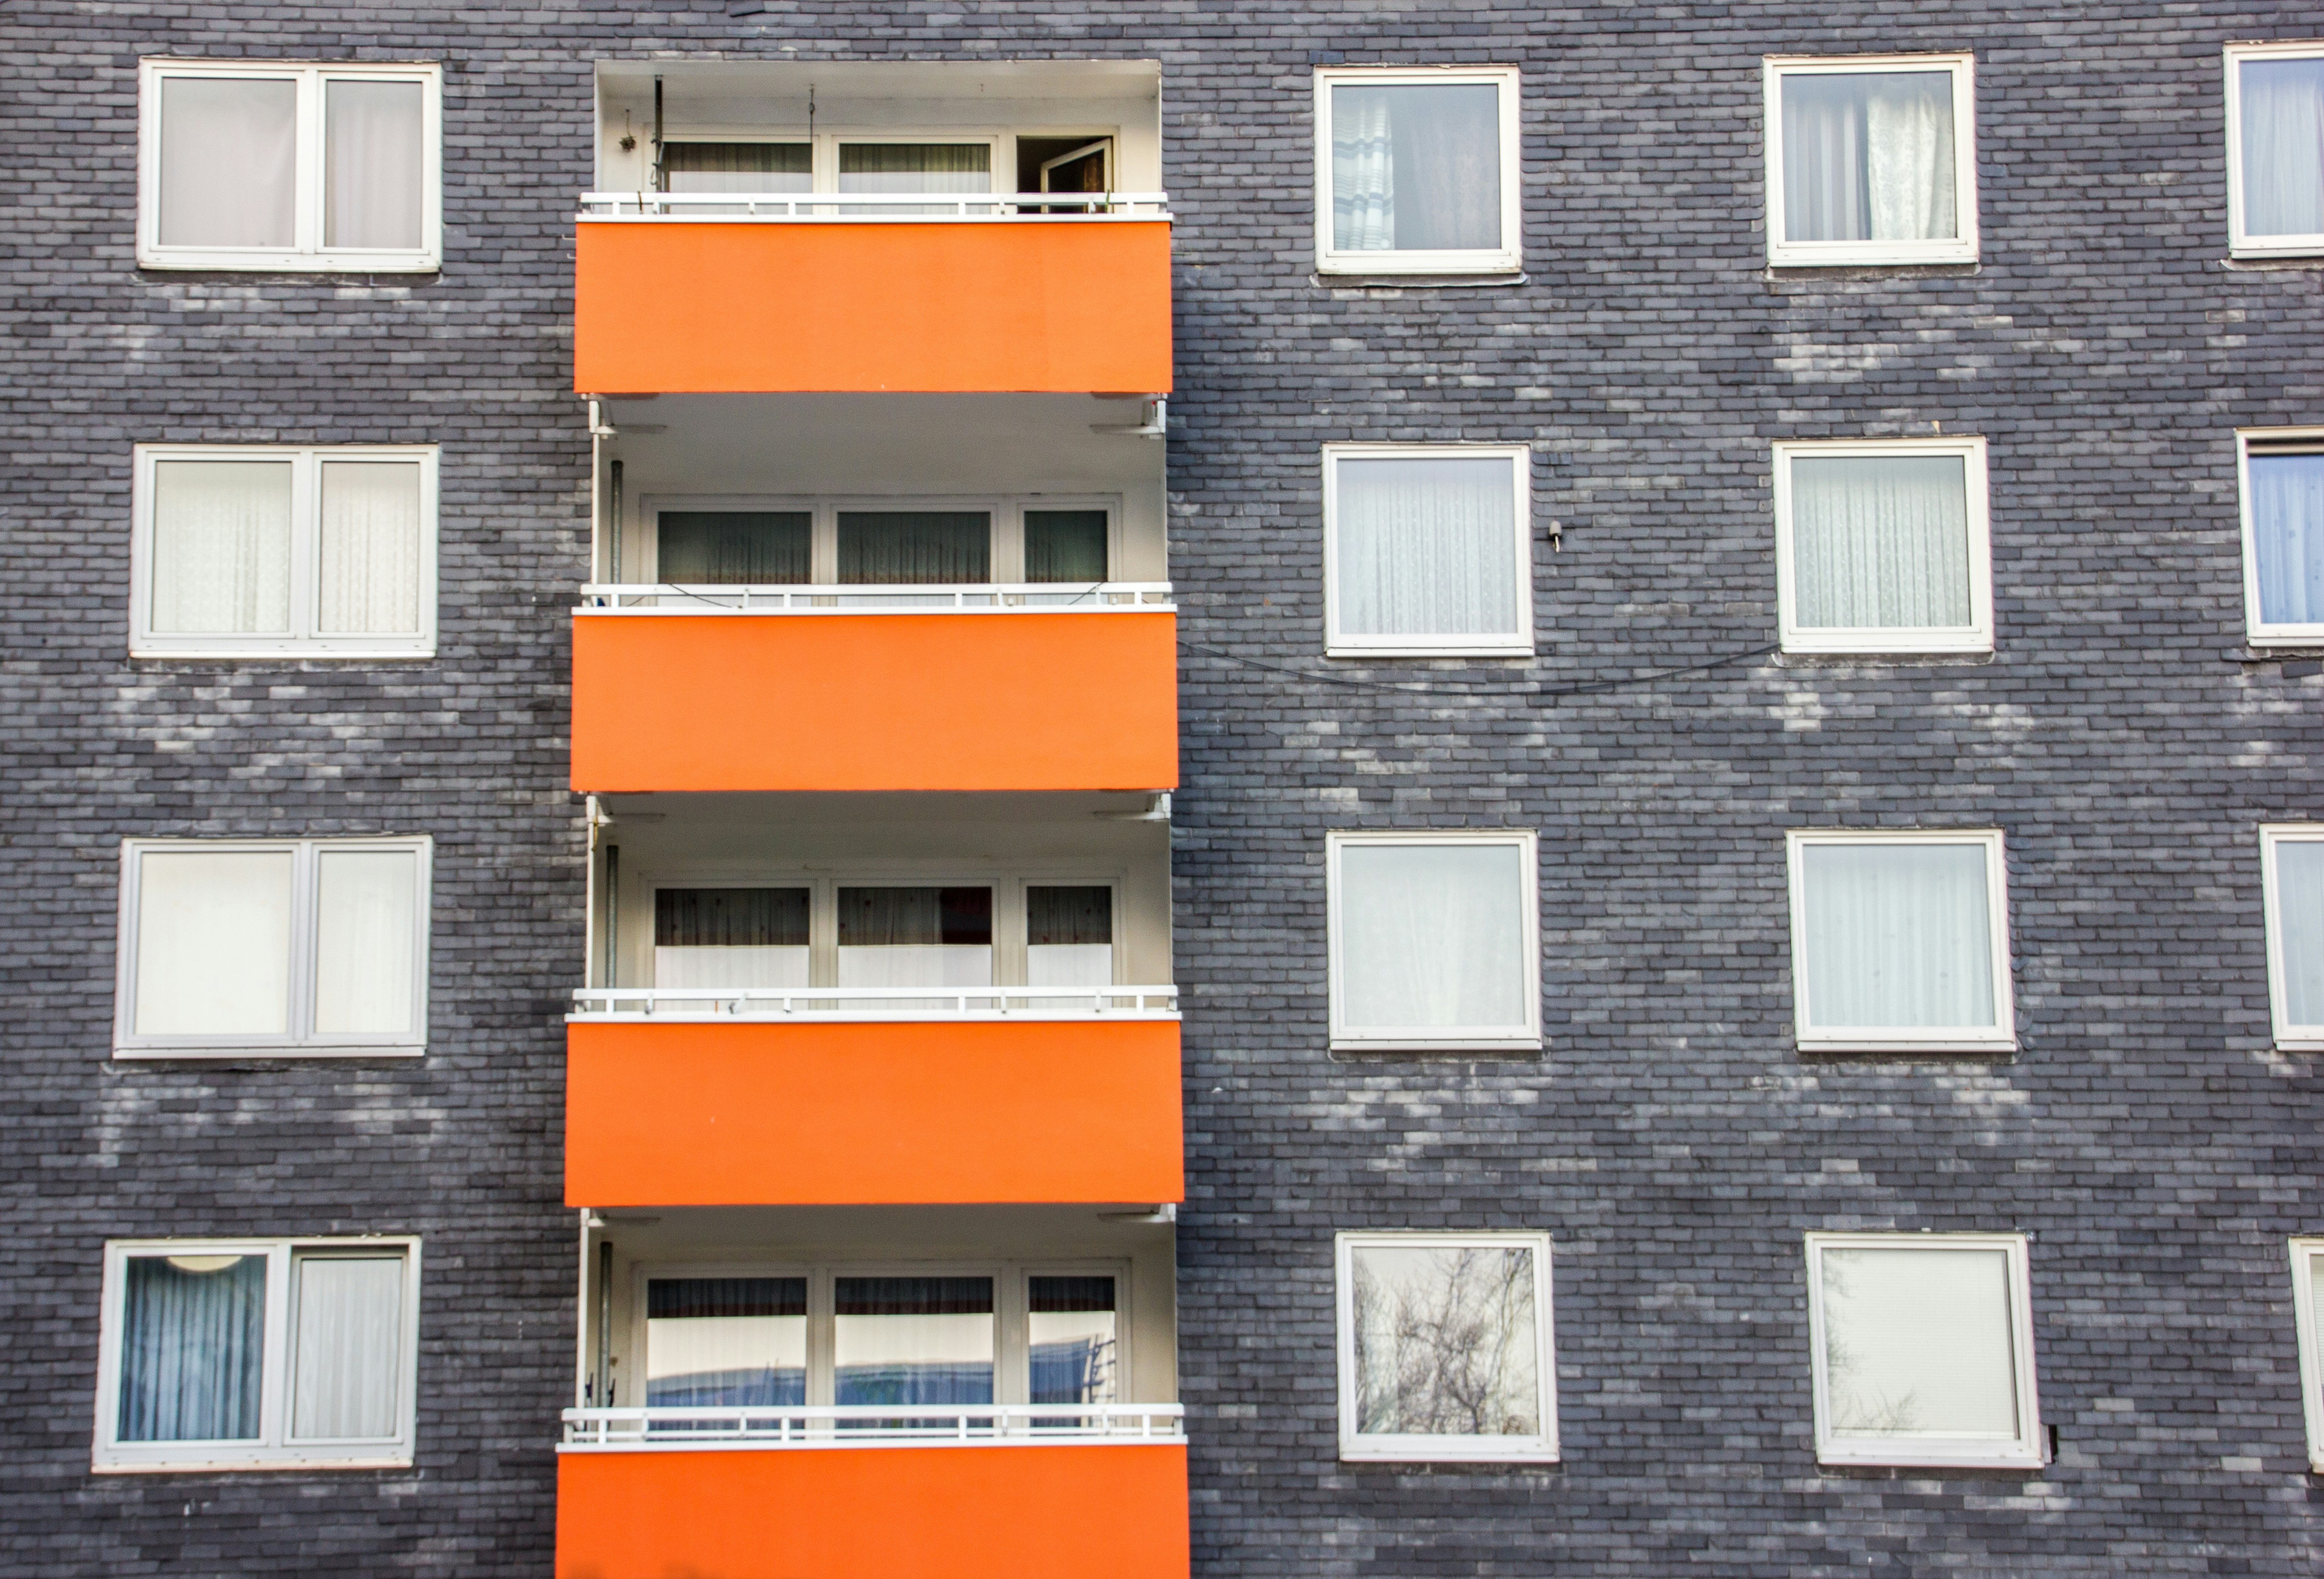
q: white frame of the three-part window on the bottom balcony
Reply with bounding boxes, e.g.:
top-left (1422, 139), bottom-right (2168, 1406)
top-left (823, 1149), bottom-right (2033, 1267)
top-left (618, 1258), bottom-right (1141, 1414)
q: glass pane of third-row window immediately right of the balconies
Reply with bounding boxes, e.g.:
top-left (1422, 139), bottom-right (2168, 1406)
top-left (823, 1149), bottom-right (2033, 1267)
top-left (1339, 844), bottom-right (1534, 1032)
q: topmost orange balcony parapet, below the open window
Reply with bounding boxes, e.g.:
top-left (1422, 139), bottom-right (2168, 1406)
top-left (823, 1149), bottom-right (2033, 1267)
top-left (574, 219), bottom-right (1171, 395)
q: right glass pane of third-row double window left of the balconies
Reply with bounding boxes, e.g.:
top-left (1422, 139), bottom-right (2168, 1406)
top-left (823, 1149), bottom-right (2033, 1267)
top-left (314, 849), bottom-right (421, 1037)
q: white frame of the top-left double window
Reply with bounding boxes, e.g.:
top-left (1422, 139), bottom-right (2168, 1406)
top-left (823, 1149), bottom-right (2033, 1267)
top-left (137, 56), bottom-right (444, 274)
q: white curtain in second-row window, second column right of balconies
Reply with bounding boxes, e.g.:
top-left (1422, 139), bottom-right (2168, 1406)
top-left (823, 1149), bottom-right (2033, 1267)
top-left (1792, 456), bottom-right (1971, 630)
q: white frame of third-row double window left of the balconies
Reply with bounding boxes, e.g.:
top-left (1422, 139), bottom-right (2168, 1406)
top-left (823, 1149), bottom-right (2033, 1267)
top-left (114, 835), bottom-right (435, 1058)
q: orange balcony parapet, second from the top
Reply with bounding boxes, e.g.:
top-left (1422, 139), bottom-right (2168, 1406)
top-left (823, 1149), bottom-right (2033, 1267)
top-left (572, 609), bottom-right (1178, 795)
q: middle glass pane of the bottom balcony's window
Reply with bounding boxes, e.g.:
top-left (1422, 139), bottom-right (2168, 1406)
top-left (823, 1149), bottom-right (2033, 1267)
top-left (832, 1276), bottom-right (992, 1405)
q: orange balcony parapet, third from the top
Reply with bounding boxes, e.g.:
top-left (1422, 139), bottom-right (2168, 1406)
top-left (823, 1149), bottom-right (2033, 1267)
top-left (565, 1019), bottom-right (1185, 1207)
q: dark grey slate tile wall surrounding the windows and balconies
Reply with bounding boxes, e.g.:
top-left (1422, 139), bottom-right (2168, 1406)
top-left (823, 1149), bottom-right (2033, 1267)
top-left (0, 0), bottom-right (2324, 1579)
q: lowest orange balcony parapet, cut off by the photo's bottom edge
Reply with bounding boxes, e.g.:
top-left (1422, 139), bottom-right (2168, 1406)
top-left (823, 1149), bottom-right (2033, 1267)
top-left (558, 1442), bottom-right (1188, 1579)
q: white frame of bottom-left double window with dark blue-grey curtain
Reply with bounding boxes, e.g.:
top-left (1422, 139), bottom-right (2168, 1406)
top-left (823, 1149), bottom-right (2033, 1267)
top-left (88, 1235), bottom-right (421, 1474)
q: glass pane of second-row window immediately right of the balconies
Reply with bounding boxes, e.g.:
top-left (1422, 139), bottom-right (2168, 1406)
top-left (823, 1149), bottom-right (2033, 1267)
top-left (1332, 458), bottom-right (1520, 635)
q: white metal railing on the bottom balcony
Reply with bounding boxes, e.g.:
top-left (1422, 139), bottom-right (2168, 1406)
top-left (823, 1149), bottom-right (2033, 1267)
top-left (565, 1405), bottom-right (1185, 1451)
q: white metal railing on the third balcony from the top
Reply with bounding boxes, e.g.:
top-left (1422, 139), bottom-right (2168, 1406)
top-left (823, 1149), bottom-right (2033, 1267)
top-left (567, 986), bottom-right (1178, 1023)
